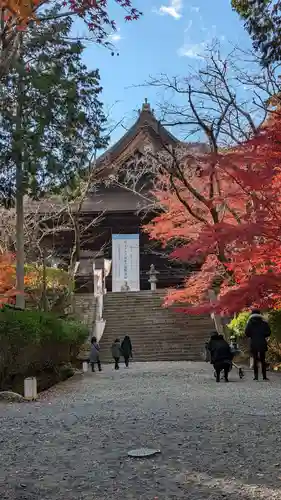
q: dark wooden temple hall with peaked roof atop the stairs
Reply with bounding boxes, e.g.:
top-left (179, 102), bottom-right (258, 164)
top-left (40, 100), bottom-right (196, 293)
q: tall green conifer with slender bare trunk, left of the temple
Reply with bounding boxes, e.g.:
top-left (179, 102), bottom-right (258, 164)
top-left (0, 11), bottom-right (107, 305)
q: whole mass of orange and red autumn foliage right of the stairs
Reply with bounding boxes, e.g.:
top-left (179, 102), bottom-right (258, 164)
top-left (146, 113), bottom-right (281, 314)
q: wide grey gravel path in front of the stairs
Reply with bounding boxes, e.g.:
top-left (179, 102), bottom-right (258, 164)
top-left (0, 363), bottom-right (281, 500)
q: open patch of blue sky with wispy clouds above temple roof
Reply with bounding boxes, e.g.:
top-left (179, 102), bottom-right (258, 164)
top-left (80, 0), bottom-right (250, 145)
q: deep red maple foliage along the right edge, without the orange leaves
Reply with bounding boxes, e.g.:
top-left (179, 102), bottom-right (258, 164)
top-left (210, 113), bottom-right (281, 312)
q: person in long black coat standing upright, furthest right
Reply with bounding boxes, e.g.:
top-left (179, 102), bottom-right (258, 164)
top-left (245, 309), bottom-right (271, 380)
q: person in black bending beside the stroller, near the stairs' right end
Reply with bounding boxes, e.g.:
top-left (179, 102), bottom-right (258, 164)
top-left (208, 332), bottom-right (233, 382)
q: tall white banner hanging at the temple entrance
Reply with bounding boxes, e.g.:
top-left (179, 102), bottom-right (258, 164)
top-left (112, 234), bottom-right (140, 292)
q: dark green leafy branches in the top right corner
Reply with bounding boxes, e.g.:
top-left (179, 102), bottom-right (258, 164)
top-left (231, 0), bottom-right (281, 66)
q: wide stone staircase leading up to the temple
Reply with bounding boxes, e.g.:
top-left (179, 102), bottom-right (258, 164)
top-left (100, 290), bottom-right (214, 362)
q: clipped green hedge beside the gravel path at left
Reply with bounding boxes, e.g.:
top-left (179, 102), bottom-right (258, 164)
top-left (0, 307), bottom-right (88, 389)
